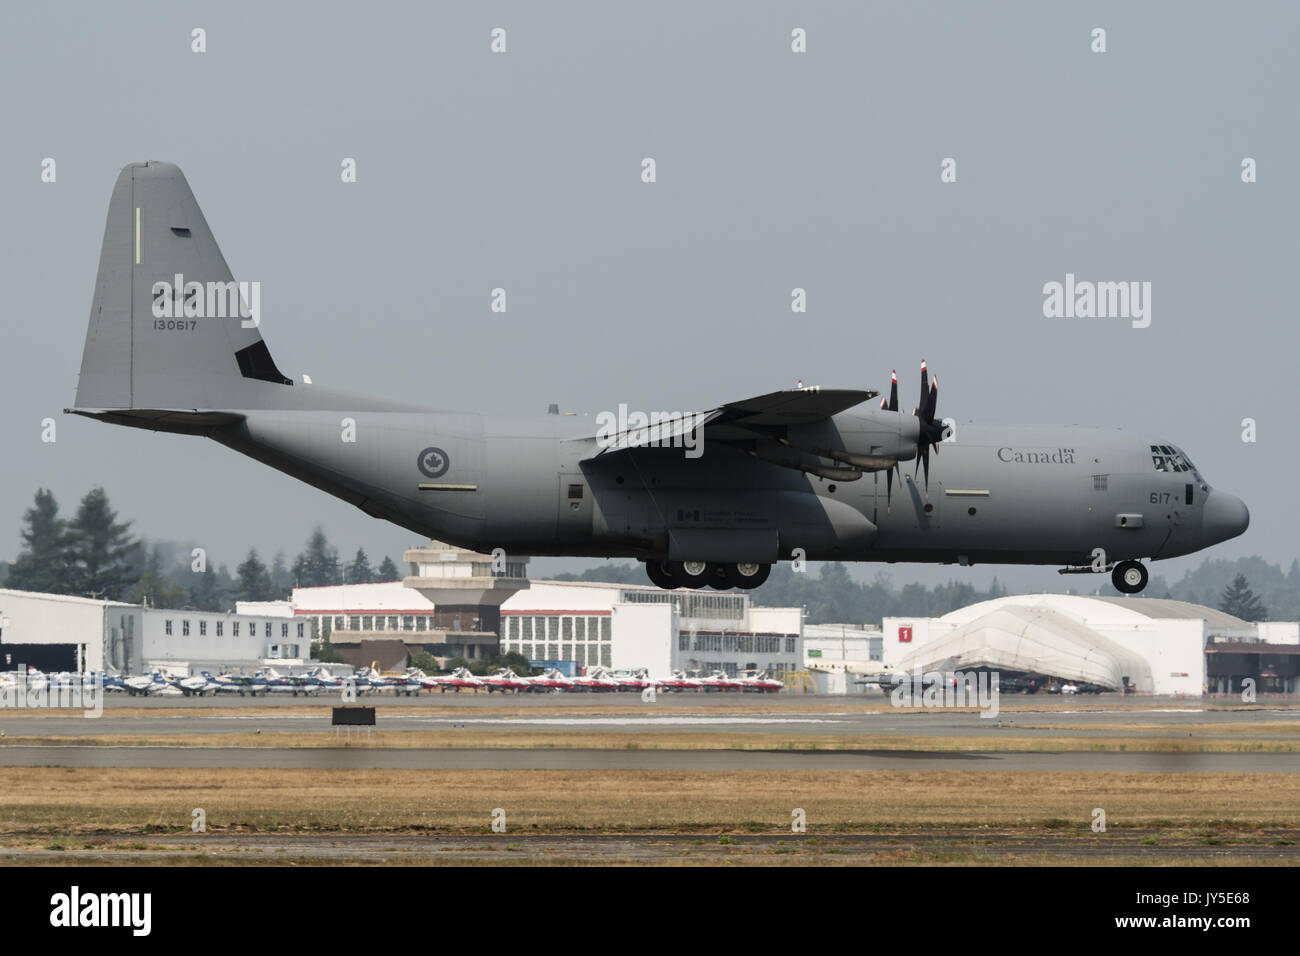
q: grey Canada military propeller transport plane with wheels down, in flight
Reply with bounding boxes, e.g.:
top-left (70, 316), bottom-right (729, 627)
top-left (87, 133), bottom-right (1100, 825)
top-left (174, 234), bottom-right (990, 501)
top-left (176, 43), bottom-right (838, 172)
top-left (68, 163), bottom-right (1249, 593)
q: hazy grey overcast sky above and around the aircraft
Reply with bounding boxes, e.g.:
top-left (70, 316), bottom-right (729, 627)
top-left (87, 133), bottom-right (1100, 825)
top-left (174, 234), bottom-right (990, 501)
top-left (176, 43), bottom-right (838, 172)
top-left (0, 1), bottom-right (1300, 588)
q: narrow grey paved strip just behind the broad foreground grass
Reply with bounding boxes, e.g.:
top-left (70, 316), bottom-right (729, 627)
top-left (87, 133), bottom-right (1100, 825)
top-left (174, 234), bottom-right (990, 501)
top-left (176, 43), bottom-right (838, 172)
top-left (0, 744), bottom-right (1300, 774)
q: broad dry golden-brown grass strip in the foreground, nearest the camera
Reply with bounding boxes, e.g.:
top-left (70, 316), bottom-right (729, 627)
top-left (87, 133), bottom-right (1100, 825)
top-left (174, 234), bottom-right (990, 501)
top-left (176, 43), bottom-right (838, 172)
top-left (0, 767), bottom-right (1300, 865)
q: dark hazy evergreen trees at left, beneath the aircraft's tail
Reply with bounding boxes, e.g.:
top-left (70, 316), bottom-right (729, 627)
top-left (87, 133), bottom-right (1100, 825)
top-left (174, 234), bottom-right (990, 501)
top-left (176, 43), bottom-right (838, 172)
top-left (0, 488), bottom-right (402, 611)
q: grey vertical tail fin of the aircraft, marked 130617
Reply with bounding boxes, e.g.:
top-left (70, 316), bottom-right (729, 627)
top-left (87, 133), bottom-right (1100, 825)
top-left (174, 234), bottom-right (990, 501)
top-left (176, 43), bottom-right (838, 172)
top-left (72, 163), bottom-right (293, 420)
